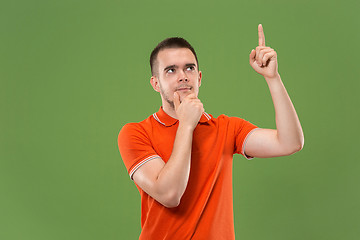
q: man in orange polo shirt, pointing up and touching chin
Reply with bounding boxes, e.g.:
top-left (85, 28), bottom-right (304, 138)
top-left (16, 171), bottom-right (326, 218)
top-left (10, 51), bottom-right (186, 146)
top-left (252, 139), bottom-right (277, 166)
top-left (118, 24), bottom-right (304, 240)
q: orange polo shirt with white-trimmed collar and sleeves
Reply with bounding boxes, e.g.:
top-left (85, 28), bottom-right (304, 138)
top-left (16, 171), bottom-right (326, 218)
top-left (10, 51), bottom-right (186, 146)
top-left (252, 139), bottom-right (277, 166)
top-left (118, 108), bottom-right (257, 240)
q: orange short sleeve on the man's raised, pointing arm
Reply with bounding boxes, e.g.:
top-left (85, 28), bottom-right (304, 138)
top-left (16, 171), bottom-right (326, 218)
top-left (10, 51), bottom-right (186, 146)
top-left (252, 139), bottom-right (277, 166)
top-left (230, 117), bottom-right (258, 159)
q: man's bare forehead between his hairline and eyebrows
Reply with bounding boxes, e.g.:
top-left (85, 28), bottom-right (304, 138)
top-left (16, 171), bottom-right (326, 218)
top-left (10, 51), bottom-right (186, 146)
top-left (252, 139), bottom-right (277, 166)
top-left (157, 48), bottom-right (197, 69)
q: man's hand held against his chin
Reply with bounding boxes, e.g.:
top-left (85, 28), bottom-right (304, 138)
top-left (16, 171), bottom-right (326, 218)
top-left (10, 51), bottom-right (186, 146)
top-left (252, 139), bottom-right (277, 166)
top-left (174, 92), bottom-right (204, 129)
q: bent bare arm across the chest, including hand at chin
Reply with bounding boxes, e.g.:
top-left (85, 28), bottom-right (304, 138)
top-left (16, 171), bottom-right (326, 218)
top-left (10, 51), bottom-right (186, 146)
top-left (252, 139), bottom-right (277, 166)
top-left (133, 93), bottom-right (204, 208)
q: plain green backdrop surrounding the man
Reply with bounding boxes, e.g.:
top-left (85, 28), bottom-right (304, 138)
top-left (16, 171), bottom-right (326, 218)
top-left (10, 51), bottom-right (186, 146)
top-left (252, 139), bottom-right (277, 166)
top-left (0, 0), bottom-right (360, 240)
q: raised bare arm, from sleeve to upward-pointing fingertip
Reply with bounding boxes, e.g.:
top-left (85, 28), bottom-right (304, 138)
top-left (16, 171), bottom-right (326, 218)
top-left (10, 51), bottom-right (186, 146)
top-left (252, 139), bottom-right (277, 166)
top-left (244, 24), bottom-right (304, 158)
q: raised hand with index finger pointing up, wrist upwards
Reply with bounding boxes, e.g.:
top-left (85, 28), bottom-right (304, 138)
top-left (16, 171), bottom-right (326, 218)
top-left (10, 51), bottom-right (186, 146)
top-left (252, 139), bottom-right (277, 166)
top-left (250, 24), bottom-right (278, 78)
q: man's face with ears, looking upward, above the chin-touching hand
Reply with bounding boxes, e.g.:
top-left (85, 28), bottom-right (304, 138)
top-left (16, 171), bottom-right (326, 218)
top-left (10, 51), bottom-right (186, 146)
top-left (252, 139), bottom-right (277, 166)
top-left (151, 48), bottom-right (201, 108)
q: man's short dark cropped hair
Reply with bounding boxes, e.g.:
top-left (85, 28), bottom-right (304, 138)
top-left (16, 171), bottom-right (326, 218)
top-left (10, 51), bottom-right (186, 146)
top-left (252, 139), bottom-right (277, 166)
top-left (150, 37), bottom-right (199, 76)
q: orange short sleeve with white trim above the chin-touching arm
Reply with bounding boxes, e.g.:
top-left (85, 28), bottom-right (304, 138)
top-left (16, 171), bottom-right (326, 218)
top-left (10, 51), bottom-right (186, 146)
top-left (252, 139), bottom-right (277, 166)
top-left (118, 123), bottom-right (160, 179)
